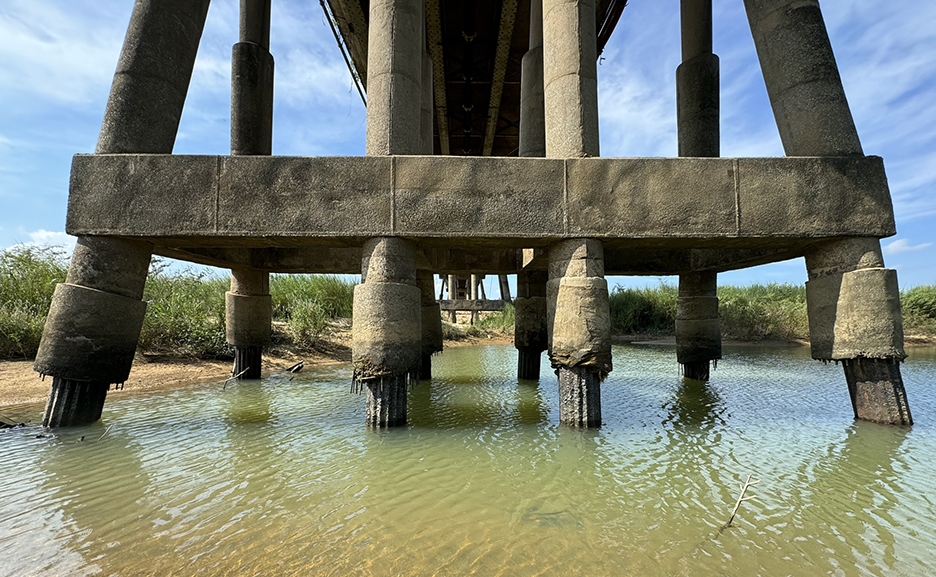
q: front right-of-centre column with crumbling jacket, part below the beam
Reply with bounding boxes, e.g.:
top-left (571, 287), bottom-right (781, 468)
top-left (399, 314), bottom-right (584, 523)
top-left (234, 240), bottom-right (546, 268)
top-left (546, 239), bottom-right (611, 427)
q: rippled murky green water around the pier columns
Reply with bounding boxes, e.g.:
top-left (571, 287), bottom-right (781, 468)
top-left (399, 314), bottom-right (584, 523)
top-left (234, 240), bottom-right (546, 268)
top-left (0, 346), bottom-right (936, 576)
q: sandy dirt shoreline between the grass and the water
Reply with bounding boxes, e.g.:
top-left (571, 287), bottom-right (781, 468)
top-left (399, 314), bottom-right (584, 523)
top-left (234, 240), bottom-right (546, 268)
top-left (0, 331), bottom-right (936, 407)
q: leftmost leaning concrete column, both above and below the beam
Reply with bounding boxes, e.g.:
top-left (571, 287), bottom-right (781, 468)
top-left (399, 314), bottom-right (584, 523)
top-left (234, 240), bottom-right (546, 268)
top-left (35, 0), bottom-right (208, 427)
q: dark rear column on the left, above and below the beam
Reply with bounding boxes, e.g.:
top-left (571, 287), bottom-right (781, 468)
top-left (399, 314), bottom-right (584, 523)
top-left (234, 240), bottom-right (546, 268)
top-left (225, 0), bottom-right (274, 379)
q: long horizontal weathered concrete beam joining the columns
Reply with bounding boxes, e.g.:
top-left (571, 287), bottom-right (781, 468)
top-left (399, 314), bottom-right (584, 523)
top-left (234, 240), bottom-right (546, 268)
top-left (66, 155), bottom-right (895, 249)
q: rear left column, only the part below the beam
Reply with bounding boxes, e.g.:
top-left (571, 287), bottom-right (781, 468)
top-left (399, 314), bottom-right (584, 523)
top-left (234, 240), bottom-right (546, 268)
top-left (224, 269), bottom-right (273, 379)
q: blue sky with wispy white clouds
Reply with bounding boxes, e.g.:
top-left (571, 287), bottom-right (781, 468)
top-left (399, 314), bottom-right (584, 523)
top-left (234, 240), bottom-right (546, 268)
top-left (0, 0), bottom-right (936, 291)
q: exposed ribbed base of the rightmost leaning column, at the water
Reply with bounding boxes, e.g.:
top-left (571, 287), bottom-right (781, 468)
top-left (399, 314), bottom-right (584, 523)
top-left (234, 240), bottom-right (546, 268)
top-left (842, 357), bottom-right (913, 425)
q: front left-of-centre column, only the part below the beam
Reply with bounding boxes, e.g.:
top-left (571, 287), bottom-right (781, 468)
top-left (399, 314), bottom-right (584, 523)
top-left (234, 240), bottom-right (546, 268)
top-left (352, 238), bottom-right (422, 427)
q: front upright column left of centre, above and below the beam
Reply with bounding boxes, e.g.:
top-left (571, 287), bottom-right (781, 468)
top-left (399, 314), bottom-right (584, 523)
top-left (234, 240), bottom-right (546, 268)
top-left (352, 0), bottom-right (425, 427)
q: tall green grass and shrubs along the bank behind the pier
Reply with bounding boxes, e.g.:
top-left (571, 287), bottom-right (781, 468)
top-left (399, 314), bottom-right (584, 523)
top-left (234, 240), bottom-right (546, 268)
top-left (0, 247), bottom-right (936, 359)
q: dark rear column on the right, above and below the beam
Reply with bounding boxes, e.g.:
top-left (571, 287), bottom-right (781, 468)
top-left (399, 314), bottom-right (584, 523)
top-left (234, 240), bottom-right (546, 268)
top-left (676, 0), bottom-right (721, 381)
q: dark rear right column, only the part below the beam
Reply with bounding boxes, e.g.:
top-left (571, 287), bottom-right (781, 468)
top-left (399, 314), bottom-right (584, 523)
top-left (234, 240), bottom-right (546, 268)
top-left (676, 272), bottom-right (721, 381)
